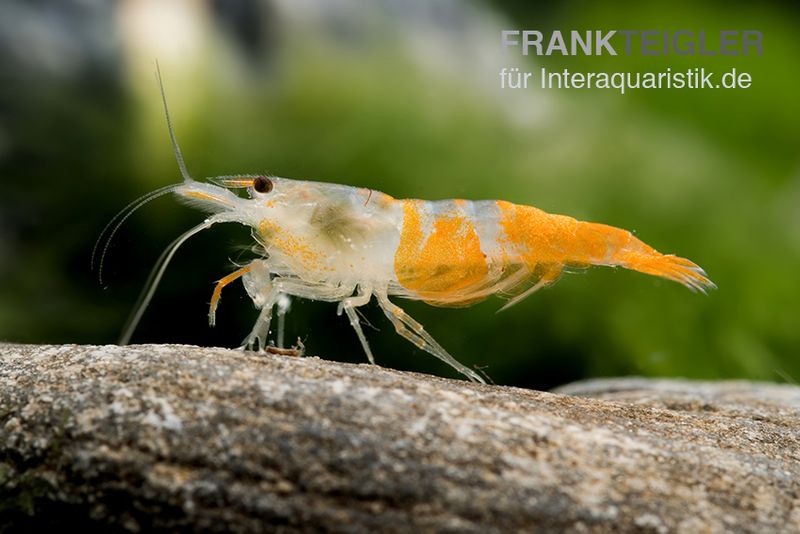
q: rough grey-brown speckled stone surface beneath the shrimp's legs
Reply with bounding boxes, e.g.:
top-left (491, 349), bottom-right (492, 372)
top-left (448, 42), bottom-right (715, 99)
top-left (0, 345), bottom-right (800, 532)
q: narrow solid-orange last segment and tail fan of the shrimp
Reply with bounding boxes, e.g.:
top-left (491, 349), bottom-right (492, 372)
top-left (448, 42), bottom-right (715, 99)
top-left (575, 222), bottom-right (717, 293)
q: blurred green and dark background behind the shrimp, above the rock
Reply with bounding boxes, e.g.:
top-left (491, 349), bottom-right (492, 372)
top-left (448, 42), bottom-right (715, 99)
top-left (0, 0), bottom-right (800, 388)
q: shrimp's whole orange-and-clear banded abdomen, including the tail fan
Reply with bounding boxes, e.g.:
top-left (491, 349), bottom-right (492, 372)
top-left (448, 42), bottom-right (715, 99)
top-left (394, 200), bottom-right (715, 307)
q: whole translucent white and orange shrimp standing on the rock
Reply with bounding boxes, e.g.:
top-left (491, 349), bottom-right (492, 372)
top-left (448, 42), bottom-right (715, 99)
top-left (109, 69), bottom-right (716, 383)
